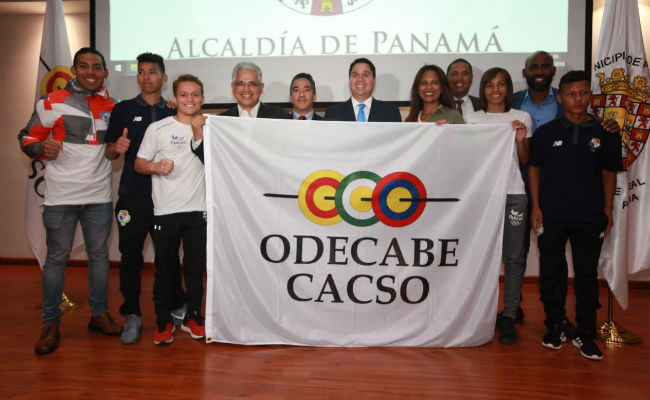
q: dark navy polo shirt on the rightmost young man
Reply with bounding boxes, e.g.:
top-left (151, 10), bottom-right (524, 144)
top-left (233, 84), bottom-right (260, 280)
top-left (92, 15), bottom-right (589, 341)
top-left (530, 117), bottom-right (621, 222)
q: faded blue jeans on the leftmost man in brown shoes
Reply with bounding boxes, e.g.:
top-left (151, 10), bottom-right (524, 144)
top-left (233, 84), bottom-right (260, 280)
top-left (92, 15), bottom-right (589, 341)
top-left (41, 203), bottom-right (113, 325)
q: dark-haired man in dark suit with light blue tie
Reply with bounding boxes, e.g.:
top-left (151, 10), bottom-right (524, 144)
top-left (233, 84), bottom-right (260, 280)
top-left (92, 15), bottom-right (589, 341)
top-left (325, 58), bottom-right (402, 122)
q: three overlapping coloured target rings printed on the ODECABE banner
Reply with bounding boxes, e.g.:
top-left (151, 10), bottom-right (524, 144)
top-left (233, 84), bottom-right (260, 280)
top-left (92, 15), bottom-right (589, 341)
top-left (298, 170), bottom-right (427, 227)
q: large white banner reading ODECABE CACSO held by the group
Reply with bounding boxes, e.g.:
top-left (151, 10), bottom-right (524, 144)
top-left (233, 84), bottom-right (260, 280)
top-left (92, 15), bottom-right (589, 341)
top-left (204, 116), bottom-right (512, 347)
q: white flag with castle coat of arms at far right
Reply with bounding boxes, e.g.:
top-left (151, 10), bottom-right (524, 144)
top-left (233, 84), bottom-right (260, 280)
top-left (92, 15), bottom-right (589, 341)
top-left (591, 0), bottom-right (650, 309)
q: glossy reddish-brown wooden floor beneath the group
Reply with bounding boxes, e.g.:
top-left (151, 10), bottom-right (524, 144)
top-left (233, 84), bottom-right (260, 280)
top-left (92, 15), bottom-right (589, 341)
top-left (0, 266), bottom-right (650, 400)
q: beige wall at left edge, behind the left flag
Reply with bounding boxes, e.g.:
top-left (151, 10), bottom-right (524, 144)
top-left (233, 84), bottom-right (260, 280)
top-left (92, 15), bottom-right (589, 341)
top-left (0, 1), bottom-right (90, 258)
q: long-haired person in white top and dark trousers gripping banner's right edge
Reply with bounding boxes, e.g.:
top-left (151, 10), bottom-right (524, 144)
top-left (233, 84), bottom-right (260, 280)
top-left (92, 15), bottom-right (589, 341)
top-left (465, 68), bottom-right (532, 344)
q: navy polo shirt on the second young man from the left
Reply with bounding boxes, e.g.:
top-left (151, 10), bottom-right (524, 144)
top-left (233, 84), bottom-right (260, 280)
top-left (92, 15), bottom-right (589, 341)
top-left (105, 95), bottom-right (176, 197)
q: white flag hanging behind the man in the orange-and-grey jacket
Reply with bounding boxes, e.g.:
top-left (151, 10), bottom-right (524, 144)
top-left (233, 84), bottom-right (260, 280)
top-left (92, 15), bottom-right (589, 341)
top-left (25, 0), bottom-right (73, 267)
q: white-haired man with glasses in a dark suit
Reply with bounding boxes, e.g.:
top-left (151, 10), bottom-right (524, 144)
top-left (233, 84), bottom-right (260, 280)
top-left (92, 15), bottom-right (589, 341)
top-left (219, 61), bottom-right (289, 119)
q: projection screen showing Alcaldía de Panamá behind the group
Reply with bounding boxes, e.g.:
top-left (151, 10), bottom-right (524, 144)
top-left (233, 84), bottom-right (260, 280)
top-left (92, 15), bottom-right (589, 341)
top-left (94, 0), bottom-right (586, 104)
